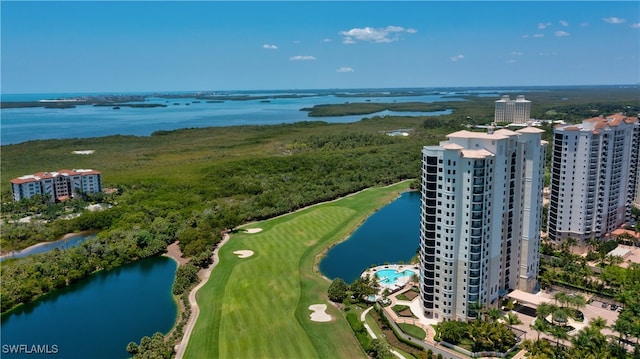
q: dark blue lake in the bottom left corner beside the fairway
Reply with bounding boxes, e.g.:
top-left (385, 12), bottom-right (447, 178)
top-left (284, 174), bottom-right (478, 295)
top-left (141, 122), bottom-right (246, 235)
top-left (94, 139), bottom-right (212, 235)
top-left (0, 257), bottom-right (177, 359)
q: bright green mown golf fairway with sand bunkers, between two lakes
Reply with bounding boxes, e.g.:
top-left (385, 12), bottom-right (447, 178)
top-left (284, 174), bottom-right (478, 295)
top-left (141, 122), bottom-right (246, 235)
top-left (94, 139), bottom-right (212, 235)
top-left (185, 181), bottom-right (409, 358)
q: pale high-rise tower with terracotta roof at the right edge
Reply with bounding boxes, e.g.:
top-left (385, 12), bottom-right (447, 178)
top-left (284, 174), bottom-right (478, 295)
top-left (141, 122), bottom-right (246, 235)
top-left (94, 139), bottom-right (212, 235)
top-left (548, 114), bottom-right (640, 242)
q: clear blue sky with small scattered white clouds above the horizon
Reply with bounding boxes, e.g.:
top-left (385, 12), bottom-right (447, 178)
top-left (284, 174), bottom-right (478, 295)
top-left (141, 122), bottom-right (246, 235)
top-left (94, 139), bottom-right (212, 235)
top-left (0, 1), bottom-right (640, 93)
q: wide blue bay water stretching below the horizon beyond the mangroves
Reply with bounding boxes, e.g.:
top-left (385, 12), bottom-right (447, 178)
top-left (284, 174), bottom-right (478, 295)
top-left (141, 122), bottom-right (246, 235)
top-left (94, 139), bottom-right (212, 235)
top-left (0, 92), bottom-right (462, 145)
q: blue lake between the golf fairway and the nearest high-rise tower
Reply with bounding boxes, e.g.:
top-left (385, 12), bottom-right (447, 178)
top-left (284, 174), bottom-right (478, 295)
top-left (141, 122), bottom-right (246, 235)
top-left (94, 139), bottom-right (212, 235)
top-left (320, 192), bottom-right (420, 283)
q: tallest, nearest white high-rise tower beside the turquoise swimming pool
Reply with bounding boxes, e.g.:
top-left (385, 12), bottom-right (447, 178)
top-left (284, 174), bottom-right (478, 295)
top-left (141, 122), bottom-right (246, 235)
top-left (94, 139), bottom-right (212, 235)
top-left (420, 127), bottom-right (547, 320)
